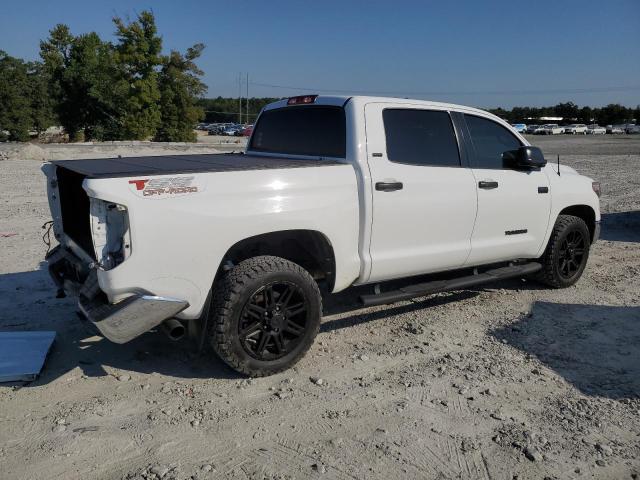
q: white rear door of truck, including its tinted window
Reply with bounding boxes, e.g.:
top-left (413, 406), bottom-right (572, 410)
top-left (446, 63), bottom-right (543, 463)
top-left (365, 103), bottom-right (477, 282)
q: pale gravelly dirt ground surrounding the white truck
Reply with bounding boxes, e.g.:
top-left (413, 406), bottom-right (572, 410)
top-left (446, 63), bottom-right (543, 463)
top-left (0, 136), bottom-right (640, 480)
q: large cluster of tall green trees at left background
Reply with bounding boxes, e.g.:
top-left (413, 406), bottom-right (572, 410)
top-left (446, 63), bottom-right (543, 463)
top-left (0, 11), bottom-right (206, 141)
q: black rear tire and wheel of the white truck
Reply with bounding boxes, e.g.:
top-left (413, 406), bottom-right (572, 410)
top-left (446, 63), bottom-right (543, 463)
top-left (208, 256), bottom-right (322, 377)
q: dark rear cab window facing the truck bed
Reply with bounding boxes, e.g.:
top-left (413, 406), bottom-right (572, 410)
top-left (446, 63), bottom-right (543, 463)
top-left (249, 105), bottom-right (347, 158)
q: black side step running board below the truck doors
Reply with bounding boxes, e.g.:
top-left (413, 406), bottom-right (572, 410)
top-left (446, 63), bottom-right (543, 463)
top-left (360, 262), bottom-right (542, 307)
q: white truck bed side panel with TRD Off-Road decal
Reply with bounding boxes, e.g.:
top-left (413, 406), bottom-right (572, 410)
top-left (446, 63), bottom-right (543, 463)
top-left (85, 165), bottom-right (360, 318)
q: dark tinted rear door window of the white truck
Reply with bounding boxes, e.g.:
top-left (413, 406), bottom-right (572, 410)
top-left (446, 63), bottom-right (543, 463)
top-left (382, 109), bottom-right (460, 167)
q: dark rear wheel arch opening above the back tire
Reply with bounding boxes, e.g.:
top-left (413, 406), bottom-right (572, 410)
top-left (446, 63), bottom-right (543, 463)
top-left (214, 230), bottom-right (336, 291)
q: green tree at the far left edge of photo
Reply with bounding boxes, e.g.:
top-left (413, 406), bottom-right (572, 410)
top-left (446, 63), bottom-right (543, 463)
top-left (0, 50), bottom-right (32, 141)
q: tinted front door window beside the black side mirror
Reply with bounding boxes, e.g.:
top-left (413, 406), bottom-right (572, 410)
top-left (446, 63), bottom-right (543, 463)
top-left (464, 115), bottom-right (522, 169)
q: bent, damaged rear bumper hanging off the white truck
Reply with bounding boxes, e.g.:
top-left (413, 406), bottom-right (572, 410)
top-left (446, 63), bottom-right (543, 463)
top-left (47, 247), bottom-right (189, 343)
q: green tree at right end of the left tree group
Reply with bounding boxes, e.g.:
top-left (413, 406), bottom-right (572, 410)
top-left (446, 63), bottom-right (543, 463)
top-left (155, 43), bottom-right (207, 142)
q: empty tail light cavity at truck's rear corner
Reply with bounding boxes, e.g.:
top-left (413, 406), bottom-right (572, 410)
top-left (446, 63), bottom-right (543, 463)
top-left (89, 198), bottom-right (131, 270)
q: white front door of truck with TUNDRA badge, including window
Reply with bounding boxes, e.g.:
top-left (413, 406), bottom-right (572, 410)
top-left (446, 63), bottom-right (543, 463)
top-left (464, 114), bottom-right (551, 265)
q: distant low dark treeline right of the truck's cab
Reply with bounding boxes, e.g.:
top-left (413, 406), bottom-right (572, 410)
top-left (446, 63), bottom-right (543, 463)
top-left (489, 102), bottom-right (640, 125)
